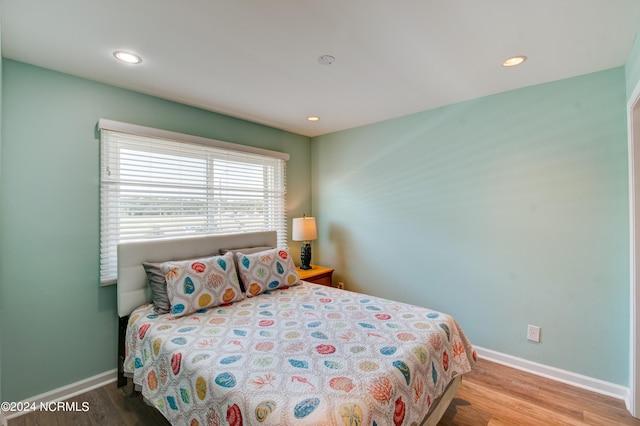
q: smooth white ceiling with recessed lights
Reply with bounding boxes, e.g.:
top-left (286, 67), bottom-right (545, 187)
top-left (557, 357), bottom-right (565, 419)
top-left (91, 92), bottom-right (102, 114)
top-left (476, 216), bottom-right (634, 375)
top-left (0, 0), bottom-right (640, 136)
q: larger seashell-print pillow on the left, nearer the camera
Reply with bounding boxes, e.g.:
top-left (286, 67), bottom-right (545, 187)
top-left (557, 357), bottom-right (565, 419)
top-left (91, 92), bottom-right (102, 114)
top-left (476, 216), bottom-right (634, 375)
top-left (161, 253), bottom-right (242, 317)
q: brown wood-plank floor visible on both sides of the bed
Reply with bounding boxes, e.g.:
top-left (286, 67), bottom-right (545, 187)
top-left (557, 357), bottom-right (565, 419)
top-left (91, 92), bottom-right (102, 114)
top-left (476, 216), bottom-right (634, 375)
top-left (8, 360), bottom-right (640, 426)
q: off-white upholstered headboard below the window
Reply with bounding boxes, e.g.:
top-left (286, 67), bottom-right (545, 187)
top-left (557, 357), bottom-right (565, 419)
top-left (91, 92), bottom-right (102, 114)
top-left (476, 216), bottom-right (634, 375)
top-left (117, 231), bottom-right (277, 317)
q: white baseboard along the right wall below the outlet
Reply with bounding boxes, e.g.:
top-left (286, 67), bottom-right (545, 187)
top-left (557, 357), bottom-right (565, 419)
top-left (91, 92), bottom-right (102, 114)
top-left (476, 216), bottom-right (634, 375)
top-left (474, 346), bottom-right (630, 409)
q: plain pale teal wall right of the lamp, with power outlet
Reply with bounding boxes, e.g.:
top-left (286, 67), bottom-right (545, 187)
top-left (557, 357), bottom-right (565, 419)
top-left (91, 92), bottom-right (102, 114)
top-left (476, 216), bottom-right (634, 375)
top-left (312, 67), bottom-right (630, 386)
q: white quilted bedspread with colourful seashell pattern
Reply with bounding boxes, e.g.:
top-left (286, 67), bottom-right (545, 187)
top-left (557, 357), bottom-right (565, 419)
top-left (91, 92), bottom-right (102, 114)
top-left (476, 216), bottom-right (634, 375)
top-left (124, 282), bottom-right (476, 426)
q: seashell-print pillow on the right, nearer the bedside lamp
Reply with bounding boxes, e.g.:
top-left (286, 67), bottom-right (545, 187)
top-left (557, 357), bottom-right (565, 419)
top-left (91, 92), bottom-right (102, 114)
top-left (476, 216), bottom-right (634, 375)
top-left (236, 247), bottom-right (300, 297)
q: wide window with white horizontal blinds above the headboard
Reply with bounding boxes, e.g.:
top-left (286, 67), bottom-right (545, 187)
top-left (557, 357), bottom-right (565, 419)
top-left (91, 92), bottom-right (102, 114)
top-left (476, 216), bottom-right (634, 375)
top-left (99, 120), bottom-right (288, 285)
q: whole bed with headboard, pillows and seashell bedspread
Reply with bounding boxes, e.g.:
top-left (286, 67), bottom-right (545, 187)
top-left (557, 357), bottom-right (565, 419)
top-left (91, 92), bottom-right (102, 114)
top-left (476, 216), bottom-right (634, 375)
top-left (117, 232), bottom-right (476, 426)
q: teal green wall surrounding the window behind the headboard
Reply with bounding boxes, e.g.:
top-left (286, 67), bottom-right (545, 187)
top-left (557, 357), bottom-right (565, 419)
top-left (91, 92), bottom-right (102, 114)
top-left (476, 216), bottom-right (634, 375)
top-left (0, 60), bottom-right (311, 401)
